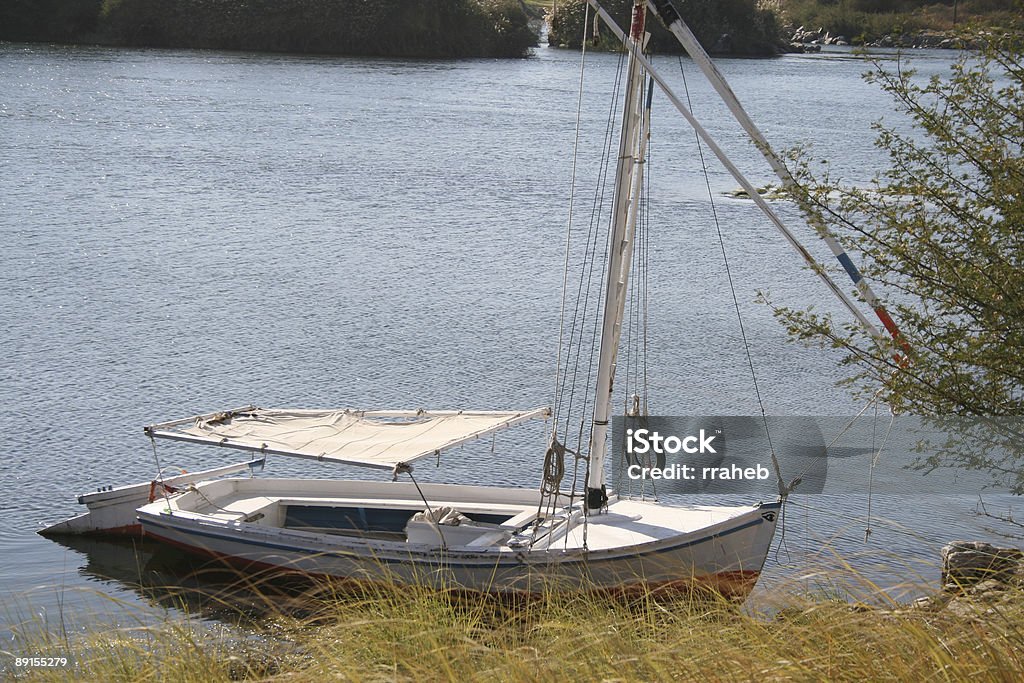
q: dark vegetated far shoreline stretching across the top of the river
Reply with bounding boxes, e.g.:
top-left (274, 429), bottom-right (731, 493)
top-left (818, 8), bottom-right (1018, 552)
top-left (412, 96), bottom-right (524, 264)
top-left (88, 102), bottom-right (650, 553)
top-left (0, 0), bottom-right (1012, 58)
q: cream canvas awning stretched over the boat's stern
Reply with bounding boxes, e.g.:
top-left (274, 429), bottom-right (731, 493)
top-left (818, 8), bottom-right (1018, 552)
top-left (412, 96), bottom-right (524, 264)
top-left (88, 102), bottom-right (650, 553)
top-left (145, 407), bottom-right (549, 469)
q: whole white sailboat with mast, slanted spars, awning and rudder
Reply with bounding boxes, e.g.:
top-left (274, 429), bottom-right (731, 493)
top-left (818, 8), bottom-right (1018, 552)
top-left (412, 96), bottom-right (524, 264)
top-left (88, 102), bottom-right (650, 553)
top-left (43, 0), bottom-right (905, 599)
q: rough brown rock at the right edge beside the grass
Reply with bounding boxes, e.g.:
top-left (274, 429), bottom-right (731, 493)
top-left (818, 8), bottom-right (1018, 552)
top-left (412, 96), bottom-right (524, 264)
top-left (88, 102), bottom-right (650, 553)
top-left (942, 541), bottom-right (1024, 594)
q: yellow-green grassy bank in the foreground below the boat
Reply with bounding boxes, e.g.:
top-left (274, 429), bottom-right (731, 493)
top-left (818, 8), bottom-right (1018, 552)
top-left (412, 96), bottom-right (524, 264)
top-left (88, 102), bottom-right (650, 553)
top-left (5, 589), bottom-right (1024, 681)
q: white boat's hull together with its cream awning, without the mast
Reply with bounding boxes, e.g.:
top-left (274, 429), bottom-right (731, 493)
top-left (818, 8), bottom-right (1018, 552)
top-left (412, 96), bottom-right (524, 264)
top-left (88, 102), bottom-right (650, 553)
top-left (119, 409), bottom-right (780, 596)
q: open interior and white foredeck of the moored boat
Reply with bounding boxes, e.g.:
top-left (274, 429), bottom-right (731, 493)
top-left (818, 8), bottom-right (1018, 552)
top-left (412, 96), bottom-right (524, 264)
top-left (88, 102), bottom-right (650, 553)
top-left (157, 479), bottom-right (754, 550)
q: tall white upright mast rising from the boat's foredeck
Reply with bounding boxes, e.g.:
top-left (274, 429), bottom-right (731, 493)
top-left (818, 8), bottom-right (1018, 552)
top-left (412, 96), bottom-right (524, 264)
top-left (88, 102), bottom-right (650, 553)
top-left (587, 0), bottom-right (647, 510)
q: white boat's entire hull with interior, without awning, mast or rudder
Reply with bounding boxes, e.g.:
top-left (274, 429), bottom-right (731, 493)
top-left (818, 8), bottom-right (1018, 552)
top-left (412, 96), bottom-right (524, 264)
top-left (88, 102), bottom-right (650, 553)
top-left (138, 479), bottom-right (779, 597)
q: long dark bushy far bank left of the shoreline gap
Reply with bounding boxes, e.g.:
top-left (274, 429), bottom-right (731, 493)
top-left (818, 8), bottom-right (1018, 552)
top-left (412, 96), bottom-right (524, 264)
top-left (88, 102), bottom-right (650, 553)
top-left (0, 0), bottom-right (537, 58)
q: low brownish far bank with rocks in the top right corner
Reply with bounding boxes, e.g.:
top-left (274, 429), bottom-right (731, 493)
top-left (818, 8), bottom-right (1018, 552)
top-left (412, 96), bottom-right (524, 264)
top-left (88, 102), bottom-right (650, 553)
top-left (772, 0), bottom-right (1022, 45)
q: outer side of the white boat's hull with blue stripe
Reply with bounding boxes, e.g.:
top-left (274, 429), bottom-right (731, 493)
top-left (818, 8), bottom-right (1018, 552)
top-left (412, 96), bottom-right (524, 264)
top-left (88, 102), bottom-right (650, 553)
top-left (139, 481), bottom-right (780, 598)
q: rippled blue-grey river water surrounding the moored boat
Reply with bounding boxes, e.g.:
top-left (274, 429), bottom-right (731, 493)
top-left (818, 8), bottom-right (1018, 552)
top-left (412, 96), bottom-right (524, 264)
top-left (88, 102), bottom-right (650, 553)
top-left (0, 38), bottom-right (1024, 622)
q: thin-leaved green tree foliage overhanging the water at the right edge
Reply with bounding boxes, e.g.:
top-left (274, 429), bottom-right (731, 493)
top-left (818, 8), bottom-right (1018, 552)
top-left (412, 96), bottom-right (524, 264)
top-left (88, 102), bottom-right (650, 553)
top-left (776, 27), bottom-right (1024, 493)
